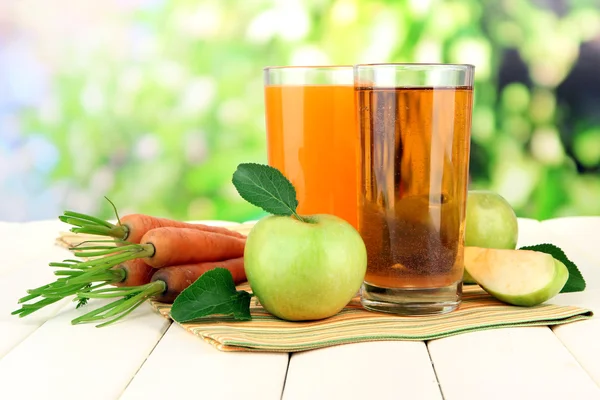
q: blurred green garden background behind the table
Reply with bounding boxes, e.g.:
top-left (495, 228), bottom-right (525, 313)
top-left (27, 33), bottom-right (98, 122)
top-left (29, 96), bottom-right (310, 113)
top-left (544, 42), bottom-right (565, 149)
top-left (0, 0), bottom-right (600, 221)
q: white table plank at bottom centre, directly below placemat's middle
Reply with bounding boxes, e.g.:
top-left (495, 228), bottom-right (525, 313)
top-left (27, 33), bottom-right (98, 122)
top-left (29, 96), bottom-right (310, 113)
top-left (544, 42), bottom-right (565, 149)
top-left (283, 341), bottom-right (442, 400)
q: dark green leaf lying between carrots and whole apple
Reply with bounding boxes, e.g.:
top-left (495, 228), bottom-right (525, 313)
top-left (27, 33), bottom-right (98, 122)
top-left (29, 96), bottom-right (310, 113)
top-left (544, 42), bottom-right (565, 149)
top-left (171, 268), bottom-right (251, 323)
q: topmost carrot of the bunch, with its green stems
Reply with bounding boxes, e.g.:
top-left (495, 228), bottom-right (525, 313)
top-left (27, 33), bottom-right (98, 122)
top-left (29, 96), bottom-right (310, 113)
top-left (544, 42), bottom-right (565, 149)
top-left (58, 199), bottom-right (246, 243)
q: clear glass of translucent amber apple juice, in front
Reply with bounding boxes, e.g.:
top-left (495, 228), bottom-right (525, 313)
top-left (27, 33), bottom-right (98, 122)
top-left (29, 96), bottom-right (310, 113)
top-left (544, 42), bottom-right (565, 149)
top-left (354, 64), bottom-right (474, 315)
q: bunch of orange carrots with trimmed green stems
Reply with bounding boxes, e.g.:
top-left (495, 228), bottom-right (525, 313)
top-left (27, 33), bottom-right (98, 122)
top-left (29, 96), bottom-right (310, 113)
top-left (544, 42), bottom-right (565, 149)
top-left (13, 203), bottom-right (246, 326)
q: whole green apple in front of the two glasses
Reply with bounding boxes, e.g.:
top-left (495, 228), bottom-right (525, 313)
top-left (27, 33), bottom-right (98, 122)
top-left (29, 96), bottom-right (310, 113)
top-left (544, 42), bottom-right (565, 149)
top-left (244, 214), bottom-right (367, 321)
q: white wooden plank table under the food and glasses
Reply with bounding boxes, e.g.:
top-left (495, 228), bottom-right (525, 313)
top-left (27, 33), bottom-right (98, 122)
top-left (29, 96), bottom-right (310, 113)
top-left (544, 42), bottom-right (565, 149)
top-left (0, 217), bottom-right (600, 400)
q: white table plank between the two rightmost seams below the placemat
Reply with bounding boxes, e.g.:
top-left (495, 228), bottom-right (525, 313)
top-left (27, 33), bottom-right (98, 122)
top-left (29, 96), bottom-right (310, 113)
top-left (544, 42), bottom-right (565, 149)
top-left (428, 327), bottom-right (600, 400)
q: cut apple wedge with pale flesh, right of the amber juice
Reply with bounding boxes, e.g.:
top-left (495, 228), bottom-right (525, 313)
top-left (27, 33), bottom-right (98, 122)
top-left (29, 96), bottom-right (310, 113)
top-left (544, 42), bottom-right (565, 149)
top-left (465, 247), bottom-right (569, 306)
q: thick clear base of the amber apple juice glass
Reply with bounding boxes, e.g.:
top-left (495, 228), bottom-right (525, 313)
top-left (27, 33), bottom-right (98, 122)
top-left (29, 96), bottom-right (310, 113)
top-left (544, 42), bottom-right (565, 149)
top-left (360, 281), bottom-right (462, 315)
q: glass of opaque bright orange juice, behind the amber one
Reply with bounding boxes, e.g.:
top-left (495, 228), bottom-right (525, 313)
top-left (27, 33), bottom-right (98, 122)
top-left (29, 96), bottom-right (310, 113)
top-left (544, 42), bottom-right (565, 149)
top-left (264, 65), bottom-right (359, 229)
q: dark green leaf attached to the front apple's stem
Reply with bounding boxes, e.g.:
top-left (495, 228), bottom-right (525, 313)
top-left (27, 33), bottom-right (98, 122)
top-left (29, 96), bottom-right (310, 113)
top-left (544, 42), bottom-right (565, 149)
top-left (232, 163), bottom-right (298, 216)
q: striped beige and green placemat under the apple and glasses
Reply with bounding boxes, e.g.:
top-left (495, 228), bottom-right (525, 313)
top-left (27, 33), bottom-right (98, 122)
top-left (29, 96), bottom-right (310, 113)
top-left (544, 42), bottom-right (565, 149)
top-left (57, 224), bottom-right (593, 352)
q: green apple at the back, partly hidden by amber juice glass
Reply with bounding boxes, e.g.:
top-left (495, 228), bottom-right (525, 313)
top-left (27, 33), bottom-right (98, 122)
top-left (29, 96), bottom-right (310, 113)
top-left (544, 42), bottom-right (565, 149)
top-left (465, 190), bottom-right (519, 250)
